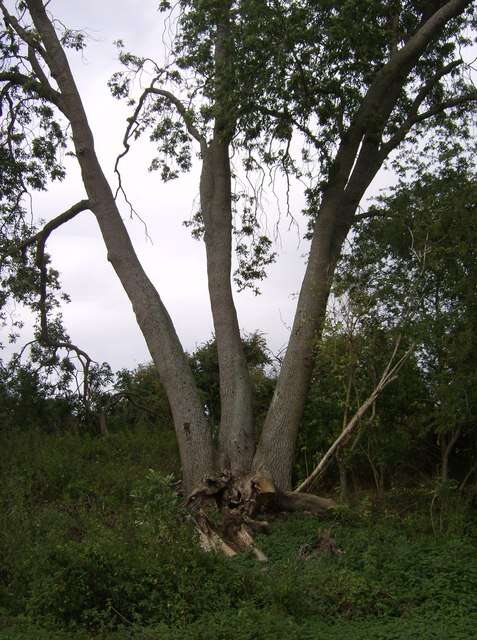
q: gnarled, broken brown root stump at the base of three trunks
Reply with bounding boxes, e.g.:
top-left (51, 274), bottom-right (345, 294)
top-left (187, 472), bottom-right (335, 561)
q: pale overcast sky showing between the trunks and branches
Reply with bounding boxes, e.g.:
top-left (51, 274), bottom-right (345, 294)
top-left (3, 0), bottom-right (389, 370)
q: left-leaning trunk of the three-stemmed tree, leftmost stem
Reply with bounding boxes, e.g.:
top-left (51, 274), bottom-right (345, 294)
top-left (27, 0), bottom-right (213, 488)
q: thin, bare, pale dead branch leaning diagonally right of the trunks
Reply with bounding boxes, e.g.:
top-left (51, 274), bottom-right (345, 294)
top-left (294, 336), bottom-right (414, 493)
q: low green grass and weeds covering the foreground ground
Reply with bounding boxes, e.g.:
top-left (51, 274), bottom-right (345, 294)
top-left (0, 429), bottom-right (477, 640)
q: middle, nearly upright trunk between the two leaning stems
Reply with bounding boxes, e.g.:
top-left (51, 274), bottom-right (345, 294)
top-left (200, 2), bottom-right (255, 476)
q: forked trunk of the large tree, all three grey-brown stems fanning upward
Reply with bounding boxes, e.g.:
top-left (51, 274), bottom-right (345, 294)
top-left (19, 0), bottom-right (470, 490)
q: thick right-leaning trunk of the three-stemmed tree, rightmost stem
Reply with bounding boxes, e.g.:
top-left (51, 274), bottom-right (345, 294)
top-left (253, 0), bottom-right (470, 490)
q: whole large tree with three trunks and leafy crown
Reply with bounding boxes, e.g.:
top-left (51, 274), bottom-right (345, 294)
top-left (0, 0), bottom-right (477, 496)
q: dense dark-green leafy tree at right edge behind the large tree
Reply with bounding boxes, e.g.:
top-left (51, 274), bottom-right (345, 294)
top-left (340, 159), bottom-right (477, 480)
